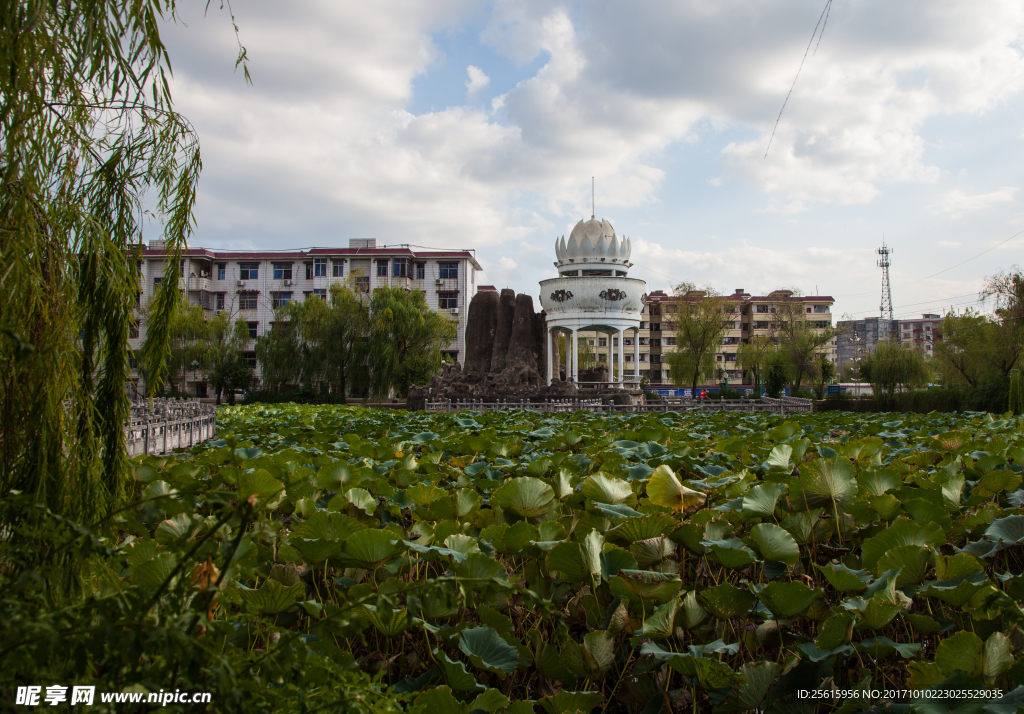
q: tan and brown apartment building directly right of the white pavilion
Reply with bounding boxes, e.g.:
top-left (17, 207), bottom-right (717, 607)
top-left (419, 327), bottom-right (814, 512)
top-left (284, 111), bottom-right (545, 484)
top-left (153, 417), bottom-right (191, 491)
top-left (586, 288), bottom-right (837, 388)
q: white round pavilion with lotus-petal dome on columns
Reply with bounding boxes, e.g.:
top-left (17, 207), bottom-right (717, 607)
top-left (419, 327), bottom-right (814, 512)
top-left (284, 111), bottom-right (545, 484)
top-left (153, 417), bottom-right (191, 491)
top-left (541, 216), bottom-right (647, 388)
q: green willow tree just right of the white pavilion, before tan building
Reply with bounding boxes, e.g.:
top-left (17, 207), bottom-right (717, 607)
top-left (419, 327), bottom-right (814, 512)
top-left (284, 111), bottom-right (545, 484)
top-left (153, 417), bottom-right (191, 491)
top-left (663, 283), bottom-right (738, 396)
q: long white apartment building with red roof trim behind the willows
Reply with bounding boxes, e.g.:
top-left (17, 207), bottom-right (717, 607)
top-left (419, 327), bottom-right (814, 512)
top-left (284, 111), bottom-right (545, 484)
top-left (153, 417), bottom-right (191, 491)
top-left (129, 239), bottom-right (482, 393)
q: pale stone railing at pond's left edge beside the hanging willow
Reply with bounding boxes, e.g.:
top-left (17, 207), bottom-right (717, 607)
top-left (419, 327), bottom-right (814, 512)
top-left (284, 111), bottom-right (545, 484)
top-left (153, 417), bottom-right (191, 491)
top-left (127, 398), bottom-right (217, 456)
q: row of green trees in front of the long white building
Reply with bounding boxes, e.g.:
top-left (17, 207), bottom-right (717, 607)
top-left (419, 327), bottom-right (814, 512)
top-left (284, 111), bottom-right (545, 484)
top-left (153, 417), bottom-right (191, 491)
top-left (142, 284), bottom-right (458, 404)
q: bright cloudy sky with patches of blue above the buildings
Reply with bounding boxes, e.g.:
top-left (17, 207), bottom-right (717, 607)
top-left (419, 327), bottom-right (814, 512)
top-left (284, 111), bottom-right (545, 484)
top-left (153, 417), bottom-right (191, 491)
top-left (157, 0), bottom-right (1024, 319)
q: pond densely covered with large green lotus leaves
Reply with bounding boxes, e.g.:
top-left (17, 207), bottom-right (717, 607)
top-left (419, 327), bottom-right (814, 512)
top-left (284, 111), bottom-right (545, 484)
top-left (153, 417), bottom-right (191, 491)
top-left (136, 406), bottom-right (1024, 714)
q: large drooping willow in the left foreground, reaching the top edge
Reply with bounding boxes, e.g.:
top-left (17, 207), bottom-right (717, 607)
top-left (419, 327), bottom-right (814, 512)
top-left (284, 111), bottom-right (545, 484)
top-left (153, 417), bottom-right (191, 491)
top-left (0, 0), bottom-right (235, 516)
